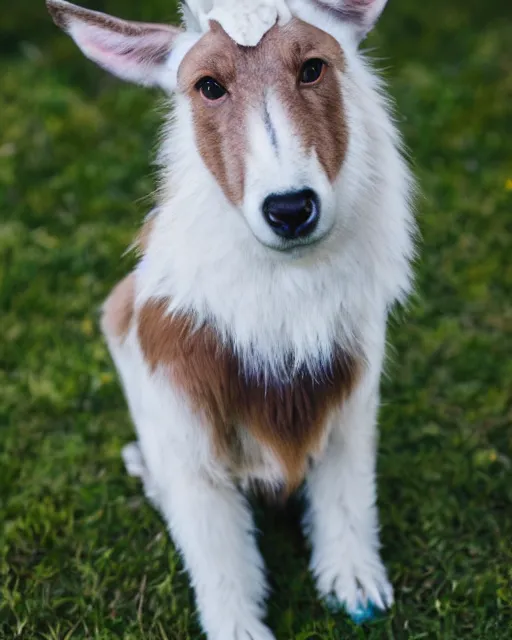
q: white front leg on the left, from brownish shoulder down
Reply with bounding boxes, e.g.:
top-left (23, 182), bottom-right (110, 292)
top-left (102, 277), bottom-right (273, 640)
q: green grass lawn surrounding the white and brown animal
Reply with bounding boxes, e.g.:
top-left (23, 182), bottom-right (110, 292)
top-left (0, 0), bottom-right (512, 640)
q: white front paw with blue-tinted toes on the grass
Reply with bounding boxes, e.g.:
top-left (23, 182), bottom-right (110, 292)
top-left (312, 543), bottom-right (393, 624)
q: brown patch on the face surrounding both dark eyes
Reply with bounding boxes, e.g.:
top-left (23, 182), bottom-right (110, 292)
top-left (179, 19), bottom-right (347, 204)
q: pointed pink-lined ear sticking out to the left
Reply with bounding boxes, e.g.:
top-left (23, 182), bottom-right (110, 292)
top-left (46, 0), bottom-right (186, 91)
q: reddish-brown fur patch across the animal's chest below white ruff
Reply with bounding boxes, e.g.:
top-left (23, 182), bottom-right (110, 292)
top-left (138, 300), bottom-right (360, 490)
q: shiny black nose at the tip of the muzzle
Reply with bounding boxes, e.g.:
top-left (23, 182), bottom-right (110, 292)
top-left (263, 189), bottom-right (320, 240)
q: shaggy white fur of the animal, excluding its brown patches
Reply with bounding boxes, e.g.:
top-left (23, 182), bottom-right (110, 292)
top-left (47, 0), bottom-right (414, 640)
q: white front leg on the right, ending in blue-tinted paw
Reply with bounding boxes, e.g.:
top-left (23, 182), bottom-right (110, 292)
top-left (305, 348), bottom-right (393, 622)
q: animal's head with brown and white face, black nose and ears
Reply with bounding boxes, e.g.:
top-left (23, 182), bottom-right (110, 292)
top-left (47, 0), bottom-right (385, 250)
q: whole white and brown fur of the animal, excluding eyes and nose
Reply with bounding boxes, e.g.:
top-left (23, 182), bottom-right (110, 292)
top-left (48, 0), bottom-right (414, 640)
